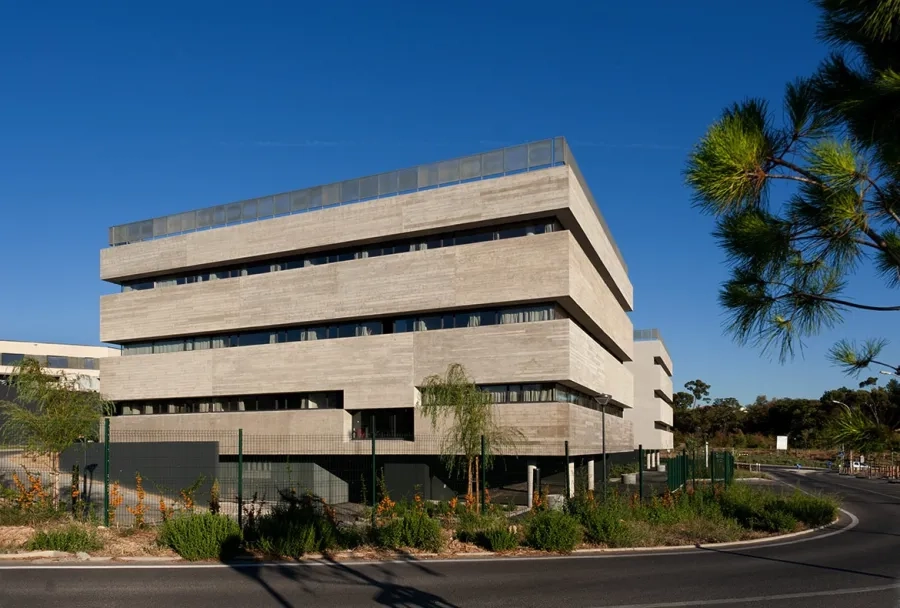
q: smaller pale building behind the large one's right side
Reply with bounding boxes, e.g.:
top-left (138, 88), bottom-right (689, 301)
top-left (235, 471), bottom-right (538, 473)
top-left (625, 329), bottom-right (674, 460)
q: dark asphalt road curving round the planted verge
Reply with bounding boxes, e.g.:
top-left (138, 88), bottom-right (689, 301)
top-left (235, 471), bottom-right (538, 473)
top-left (0, 472), bottom-right (900, 608)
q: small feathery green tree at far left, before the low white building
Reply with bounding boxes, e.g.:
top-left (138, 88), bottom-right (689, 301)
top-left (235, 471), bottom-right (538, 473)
top-left (0, 358), bottom-right (109, 504)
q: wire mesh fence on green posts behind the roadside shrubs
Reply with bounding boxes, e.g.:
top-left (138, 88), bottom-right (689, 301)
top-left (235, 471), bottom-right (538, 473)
top-left (0, 426), bottom-right (684, 527)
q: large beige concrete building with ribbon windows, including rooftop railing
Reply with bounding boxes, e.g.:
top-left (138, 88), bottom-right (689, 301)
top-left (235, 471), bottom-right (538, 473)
top-left (100, 138), bottom-right (636, 456)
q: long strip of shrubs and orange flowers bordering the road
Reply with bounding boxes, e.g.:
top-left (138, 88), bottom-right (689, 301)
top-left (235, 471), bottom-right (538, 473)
top-left (0, 460), bottom-right (838, 560)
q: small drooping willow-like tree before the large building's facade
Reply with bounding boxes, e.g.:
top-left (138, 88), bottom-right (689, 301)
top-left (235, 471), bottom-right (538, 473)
top-left (422, 363), bottom-right (523, 504)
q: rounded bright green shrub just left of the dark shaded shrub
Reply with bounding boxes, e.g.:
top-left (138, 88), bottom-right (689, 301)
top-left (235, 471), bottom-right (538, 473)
top-left (156, 513), bottom-right (241, 560)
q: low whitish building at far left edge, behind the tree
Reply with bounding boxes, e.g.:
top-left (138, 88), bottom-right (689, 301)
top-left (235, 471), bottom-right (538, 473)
top-left (0, 340), bottom-right (120, 391)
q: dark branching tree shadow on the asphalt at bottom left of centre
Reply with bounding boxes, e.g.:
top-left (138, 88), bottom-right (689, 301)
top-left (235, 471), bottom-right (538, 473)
top-left (219, 554), bottom-right (459, 608)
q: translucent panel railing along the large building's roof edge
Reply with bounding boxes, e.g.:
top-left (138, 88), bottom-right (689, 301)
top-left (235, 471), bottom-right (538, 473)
top-left (109, 137), bottom-right (625, 266)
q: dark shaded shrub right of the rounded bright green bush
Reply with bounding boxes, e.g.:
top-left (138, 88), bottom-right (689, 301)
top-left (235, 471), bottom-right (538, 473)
top-left (245, 491), bottom-right (350, 558)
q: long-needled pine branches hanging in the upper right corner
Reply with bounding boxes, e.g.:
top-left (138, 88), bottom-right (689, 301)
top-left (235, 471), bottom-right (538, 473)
top-left (686, 0), bottom-right (900, 360)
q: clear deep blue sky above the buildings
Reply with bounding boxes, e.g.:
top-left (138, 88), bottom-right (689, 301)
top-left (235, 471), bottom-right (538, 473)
top-left (0, 0), bottom-right (900, 401)
